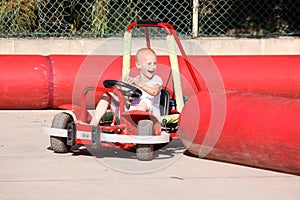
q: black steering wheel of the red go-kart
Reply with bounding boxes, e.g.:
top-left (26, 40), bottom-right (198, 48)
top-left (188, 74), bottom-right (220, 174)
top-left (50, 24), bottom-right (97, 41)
top-left (103, 80), bottom-right (142, 97)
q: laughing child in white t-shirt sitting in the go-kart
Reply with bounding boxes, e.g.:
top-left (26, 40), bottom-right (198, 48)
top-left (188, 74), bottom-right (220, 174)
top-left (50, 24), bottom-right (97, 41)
top-left (91, 48), bottom-right (162, 125)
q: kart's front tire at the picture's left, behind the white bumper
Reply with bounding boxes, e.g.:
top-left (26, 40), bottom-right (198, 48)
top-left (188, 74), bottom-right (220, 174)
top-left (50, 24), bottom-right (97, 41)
top-left (50, 113), bottom-right (73, 153)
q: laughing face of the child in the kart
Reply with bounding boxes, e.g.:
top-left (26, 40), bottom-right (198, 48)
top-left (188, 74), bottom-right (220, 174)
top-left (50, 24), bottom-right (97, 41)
top-left (136, 53), bottom-right (157, 79)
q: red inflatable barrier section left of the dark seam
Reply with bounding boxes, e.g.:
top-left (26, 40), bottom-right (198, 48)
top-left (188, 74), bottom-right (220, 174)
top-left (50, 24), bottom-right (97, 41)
top-left (0, 55), bottom-right (51, 109)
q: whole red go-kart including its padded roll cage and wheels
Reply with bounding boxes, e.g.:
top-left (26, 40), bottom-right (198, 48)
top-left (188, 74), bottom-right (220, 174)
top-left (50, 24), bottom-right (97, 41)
top-left (44, 21), bottom-right (202, 160)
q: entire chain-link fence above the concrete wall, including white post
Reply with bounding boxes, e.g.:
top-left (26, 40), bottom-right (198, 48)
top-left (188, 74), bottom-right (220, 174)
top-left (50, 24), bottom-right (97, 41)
top-left (0, 0), bottom-right (300, 38)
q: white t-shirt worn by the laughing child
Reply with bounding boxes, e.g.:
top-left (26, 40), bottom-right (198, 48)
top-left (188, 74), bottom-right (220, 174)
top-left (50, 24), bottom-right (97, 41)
top-left (130, 75), bottom-right (163, 117)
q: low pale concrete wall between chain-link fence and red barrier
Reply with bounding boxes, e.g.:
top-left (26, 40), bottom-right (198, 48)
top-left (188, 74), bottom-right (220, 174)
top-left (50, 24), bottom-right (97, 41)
top-left (0, 37), bottom-right (300, 55)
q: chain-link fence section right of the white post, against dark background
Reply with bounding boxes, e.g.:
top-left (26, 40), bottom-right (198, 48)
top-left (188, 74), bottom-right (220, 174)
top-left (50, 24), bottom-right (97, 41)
top-left (199, 0), bottom-right (300, 37)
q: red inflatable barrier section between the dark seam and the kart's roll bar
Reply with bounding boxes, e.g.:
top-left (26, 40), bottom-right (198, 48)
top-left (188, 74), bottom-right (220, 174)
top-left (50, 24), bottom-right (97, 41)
top-left (50, 55), bottom-right (122, 108)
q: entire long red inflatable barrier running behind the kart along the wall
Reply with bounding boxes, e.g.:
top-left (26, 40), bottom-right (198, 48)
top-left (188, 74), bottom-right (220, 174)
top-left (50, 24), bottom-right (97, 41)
top-left (0, 55), bottom-right (300, 109)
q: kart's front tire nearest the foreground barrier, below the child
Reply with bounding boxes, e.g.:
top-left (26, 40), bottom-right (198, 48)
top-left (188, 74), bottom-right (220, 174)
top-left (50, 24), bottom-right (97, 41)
top-left (136, 120), bottom-right (154, 161)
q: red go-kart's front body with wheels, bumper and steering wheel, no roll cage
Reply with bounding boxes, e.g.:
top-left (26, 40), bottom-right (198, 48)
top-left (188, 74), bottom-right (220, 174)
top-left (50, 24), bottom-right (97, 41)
top-left (43, 80), bottom-right (170, 160)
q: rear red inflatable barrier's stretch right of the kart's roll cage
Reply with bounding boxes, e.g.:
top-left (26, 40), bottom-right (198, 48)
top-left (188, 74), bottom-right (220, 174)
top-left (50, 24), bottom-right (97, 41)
top-left (189, 55), bottom-right (300, 98)
